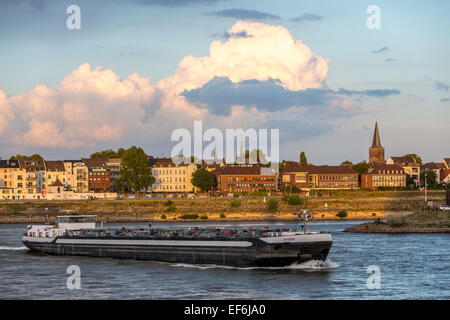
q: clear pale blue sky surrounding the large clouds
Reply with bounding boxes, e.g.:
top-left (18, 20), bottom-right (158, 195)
top-left (0, 0), bottom-right (450, 164)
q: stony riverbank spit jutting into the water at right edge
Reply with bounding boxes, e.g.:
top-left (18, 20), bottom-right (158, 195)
top-left (344, 211), bottom-right (450, 234)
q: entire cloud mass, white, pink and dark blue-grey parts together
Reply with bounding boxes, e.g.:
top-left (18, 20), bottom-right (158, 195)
top-left (0, 21), bottom-right (386, 156)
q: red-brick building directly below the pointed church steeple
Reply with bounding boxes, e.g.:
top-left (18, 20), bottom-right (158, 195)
top-left (361, 164), bottom-right (406, 189)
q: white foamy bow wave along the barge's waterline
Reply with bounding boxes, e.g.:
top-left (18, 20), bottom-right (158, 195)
top-left (171, 259), bottom-right (339, 271)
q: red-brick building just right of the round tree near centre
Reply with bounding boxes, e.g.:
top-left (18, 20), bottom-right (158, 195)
top-left (214, 166), bottom-right (277, 193)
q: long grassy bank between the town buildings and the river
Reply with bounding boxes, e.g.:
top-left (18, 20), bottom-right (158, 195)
top-left (0, 190), bottom-right (445, 223)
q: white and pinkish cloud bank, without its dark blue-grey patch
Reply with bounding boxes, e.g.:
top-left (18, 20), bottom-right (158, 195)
top-left (0, 21), bottom-right (353, 155)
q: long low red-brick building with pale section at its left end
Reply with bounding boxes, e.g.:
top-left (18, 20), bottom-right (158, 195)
top-left (281, 163), bottom-right (359, 189)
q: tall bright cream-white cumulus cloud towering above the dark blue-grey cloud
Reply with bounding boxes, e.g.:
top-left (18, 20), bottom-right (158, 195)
top-left (157, 21), bottom-right (330, 94)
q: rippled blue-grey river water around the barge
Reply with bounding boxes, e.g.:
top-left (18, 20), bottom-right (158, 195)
top-left (0, 221), bottom-right (450, 299)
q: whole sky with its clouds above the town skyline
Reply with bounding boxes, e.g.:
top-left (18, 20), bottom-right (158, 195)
top-left (0, 0), bottom-right (450, 165)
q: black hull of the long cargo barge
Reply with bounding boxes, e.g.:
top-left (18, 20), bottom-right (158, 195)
top-left (23, 239), bottom-right (332, 267)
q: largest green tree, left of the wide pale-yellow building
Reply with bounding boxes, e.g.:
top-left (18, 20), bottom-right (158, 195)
top-left (120, 146), bottom-right (155, 193)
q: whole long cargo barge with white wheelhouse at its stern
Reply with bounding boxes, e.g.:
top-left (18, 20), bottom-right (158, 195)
top-left (22, 215), bottom-right (332, 267)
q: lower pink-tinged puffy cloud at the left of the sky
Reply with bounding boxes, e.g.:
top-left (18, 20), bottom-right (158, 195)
top-left (4, 64), bottom-right (154, 147)
